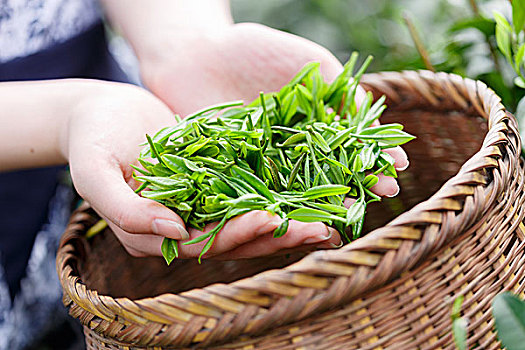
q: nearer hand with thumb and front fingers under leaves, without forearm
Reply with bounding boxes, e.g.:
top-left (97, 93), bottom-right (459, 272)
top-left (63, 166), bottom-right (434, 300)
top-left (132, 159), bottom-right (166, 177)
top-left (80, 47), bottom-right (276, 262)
top-left (63, 83), bottom-right (341, 259)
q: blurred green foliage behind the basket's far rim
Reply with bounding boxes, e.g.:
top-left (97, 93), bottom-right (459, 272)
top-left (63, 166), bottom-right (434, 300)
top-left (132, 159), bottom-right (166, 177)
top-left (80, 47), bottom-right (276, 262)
top-left (232, 0), bottom-right (525, 111)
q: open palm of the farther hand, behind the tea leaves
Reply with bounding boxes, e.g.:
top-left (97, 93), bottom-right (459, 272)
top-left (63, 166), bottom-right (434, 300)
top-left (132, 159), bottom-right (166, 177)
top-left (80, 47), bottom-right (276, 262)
top-left (143, 24), bottom-right (342, 115)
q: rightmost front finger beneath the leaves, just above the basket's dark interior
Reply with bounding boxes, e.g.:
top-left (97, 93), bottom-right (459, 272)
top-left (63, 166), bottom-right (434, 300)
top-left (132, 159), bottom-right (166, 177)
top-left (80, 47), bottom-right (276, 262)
top-left (209, 220), bottom-right (342, 260)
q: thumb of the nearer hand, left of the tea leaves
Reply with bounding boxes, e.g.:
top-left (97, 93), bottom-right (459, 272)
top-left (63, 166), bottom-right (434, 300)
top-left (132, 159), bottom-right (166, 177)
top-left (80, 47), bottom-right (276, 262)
top-left (71, 159), bottom-right (189, 239)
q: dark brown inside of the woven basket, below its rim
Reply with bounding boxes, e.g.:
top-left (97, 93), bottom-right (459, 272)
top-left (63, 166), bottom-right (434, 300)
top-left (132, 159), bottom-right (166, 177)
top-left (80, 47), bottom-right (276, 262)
top-left (79, 109), bottom-right (487, 299)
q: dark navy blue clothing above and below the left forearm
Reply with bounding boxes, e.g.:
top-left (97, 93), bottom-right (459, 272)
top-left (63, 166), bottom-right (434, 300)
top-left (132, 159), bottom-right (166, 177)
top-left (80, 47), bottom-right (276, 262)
top-left (0, 22), bottom-right (127, 296)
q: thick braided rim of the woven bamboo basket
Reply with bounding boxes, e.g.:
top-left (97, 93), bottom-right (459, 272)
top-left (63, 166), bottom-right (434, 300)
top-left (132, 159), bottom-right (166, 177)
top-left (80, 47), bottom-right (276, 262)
top-left (57, 71), bottom-right (521, 346)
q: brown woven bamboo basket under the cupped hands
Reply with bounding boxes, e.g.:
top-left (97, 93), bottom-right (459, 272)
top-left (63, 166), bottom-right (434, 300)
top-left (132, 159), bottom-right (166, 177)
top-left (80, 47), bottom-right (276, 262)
top-left (57, 71), bottom-right (525, 350)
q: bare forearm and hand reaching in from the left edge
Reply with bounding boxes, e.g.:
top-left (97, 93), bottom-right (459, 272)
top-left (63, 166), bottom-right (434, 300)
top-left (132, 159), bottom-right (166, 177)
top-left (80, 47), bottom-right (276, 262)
top-left (0, 80), bottom-right (400, 259)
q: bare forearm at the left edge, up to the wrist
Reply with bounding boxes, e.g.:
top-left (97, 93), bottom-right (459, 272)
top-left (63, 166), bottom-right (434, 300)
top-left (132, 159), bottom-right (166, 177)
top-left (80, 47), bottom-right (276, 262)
top-left (0, 79), bottom-right (106, 171)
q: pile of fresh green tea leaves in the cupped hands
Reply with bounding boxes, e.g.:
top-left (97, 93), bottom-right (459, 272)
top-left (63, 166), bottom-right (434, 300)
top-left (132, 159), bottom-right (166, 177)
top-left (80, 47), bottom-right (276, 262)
top-left (135, 53), bottom-right (414, 264)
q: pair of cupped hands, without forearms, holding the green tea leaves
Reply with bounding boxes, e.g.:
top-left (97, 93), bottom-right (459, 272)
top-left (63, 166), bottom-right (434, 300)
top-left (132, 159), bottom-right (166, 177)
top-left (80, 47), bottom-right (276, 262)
top-left (69, 24), bottom-right (408, 259)
